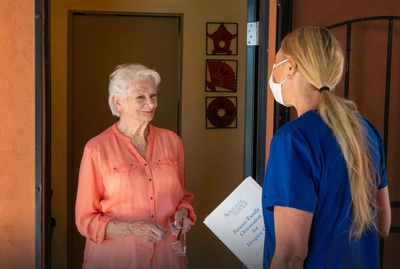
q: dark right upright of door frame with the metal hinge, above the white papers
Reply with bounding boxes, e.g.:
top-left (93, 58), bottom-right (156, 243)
top-left (243, 0), bottom-right (271, 186)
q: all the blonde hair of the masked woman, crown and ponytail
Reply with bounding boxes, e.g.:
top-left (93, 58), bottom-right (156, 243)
top-left (281, 27), bottom-right (378, 239)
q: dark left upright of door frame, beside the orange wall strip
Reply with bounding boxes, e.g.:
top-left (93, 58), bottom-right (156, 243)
top-left (34, 0), bottom-right (51, 269)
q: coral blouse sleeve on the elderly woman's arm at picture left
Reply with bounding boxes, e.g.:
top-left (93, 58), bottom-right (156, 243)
top-left (75, 146), bottom-right (111, 243)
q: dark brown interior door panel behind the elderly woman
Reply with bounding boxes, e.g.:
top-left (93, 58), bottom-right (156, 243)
top-left (52, 12), bottom-right (182, 268)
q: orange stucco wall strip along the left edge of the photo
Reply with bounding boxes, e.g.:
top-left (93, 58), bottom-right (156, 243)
top-left (0, 0), bottom-right (35, 269)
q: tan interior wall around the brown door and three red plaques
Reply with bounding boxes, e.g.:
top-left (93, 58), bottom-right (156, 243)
top-left (51, 0), bottom-right (247, 269)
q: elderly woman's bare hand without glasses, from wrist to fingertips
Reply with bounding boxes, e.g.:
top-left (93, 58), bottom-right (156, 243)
top-left (130, 220), bottom-right (167, 243)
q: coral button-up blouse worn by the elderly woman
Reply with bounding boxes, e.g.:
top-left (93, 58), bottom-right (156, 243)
top-left (75, 124), bottom-right (196, 269)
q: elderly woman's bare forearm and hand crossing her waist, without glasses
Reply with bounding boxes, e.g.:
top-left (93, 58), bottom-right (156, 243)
top-left (105, 220), bottom-right (167, 243)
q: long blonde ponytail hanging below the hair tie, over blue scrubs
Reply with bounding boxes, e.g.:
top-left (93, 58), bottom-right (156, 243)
top-left (319, 92), bottom-right (378, 239)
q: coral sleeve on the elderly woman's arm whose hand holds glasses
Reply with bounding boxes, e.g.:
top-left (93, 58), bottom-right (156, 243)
top-left (176, 137), bottom-right (197, 225)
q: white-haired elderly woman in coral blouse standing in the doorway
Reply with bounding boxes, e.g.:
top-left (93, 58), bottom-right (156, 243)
top-left (75, 64), bottom-right (196, 269)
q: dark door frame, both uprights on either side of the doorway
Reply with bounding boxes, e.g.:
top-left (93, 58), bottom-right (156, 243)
top-left (34, 0), bottom-right (260, 269)
